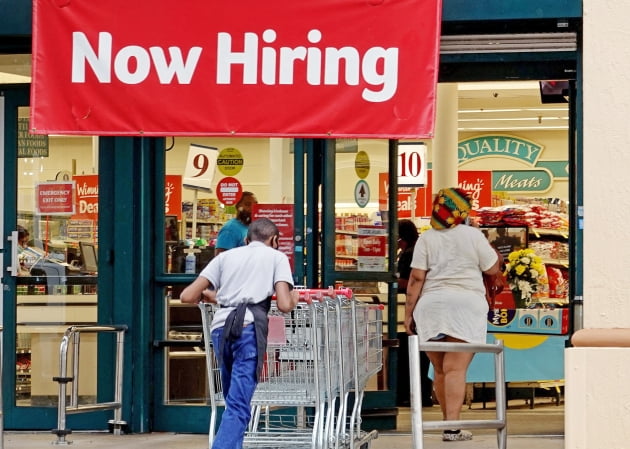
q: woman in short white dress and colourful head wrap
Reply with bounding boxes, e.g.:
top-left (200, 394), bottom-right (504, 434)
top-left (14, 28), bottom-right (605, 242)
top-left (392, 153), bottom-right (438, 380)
top-left (405, 188), bottom-right (500, 441)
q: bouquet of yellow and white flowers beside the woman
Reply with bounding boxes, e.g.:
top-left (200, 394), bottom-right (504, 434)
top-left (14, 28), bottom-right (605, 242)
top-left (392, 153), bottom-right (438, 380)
top-left (505, 248), bottom-right (546, 308)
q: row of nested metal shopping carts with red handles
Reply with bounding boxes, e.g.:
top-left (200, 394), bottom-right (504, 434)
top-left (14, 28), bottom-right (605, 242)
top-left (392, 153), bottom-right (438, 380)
top-left (200, 288), bottom-right (383, 449)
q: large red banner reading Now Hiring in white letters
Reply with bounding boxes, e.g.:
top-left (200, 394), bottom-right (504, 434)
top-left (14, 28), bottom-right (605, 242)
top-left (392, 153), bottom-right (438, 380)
top-left (30, 0), bottom-right (442, 138)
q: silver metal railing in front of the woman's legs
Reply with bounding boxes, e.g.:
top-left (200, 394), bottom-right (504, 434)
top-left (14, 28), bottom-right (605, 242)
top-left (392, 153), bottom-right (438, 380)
top-left (409, 335), bottom-right (507, 449)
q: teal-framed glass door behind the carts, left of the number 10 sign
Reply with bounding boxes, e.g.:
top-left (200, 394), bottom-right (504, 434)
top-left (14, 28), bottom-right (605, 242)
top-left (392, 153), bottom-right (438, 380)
top-left (321, 139), bottom-right (404, 428)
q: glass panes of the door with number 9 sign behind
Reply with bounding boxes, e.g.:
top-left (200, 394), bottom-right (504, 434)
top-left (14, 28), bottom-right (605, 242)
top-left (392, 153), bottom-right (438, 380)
top-left (162, 137), bottom-right (294, 405)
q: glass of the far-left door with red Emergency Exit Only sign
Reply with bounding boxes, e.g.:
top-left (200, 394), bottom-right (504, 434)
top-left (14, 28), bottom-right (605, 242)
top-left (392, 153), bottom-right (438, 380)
top-left (16, 107), bottom-right (98, 407)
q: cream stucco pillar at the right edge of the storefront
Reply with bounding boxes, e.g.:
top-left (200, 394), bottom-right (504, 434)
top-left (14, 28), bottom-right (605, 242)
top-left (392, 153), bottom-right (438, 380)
top-left (565, 0), bottom-right (630, 449)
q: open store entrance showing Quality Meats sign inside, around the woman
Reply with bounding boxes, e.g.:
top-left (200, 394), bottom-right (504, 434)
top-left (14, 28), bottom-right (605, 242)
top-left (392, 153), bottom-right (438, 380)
top-left (397, 75), bottom-right (580, 428)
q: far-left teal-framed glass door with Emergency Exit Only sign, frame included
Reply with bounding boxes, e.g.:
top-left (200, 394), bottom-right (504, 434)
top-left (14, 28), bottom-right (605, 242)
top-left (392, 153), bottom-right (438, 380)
top-left (0, 88), bottom-right (107, 429)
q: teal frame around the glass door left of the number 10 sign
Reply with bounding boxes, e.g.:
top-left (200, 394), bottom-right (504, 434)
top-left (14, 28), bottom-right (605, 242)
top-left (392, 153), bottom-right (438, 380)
top-left (294, 139), bottom-right (398, 429)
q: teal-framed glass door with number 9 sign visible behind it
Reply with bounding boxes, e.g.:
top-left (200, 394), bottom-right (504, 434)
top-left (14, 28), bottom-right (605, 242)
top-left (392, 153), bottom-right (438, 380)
top-left (153, 136), bottom-right (293, 433)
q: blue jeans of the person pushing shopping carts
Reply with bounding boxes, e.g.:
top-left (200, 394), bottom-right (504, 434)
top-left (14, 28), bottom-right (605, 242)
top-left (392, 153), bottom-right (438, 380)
top-left (212, 324), bottom-right (258, 449)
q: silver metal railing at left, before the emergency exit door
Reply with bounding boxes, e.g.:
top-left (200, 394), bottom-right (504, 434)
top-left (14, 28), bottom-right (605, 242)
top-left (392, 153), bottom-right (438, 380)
top-left (52, 325), bottom-right (127, 445)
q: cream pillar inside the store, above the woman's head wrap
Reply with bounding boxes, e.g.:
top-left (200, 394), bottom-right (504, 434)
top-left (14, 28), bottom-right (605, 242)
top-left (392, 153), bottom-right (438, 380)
top-left (431, 83), bottom-right (459, 193)
